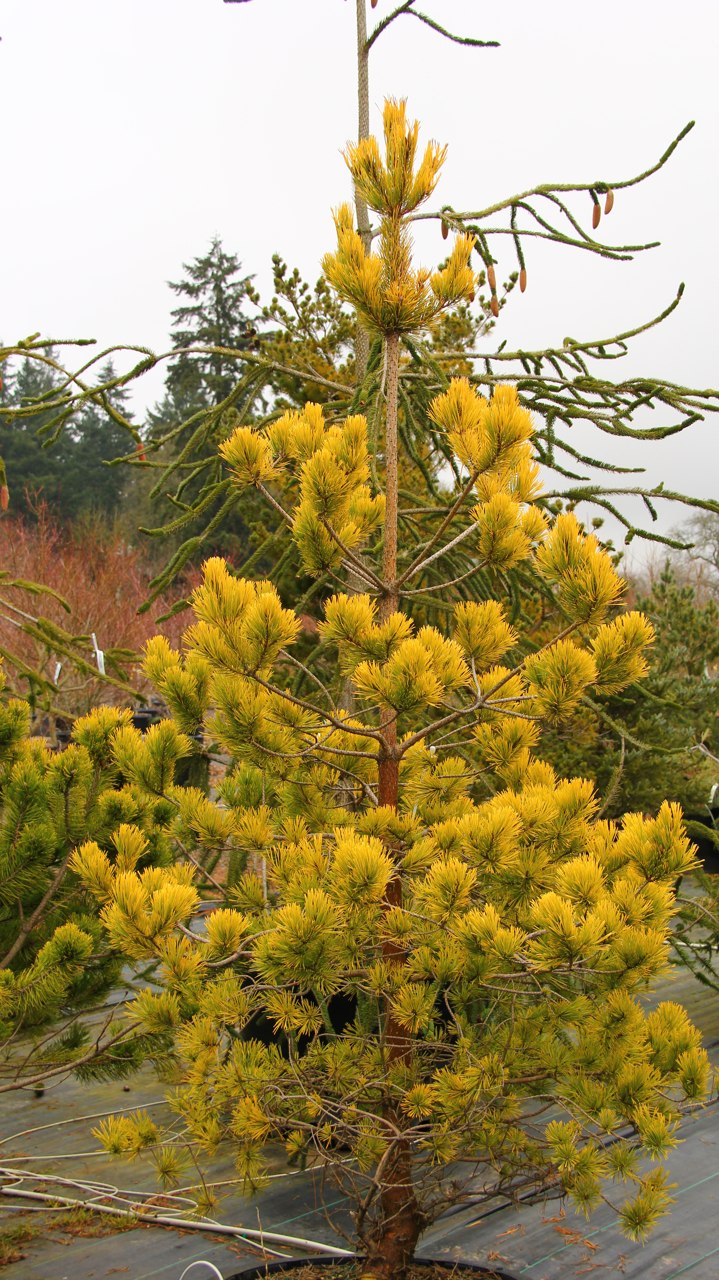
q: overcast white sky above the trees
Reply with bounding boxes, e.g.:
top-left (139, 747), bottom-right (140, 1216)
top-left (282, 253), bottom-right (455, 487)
top-left (0, 0), bottom-right (719, 545)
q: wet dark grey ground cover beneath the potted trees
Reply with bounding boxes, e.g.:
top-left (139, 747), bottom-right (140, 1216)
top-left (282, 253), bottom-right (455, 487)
top-left (0, 969), bottom-right (719, 1280)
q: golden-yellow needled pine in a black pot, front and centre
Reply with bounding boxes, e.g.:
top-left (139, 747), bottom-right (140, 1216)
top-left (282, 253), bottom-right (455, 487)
top-left (73, 110), bottom-right (707, 1280)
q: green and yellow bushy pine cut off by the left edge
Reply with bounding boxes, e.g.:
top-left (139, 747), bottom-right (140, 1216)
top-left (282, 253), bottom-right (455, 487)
top-left (0, 669), bottom-right (192, 1091)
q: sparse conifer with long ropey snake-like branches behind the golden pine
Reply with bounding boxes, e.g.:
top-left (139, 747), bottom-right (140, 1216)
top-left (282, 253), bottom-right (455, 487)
top-left (122, 0), bottom-right (719, 609)
